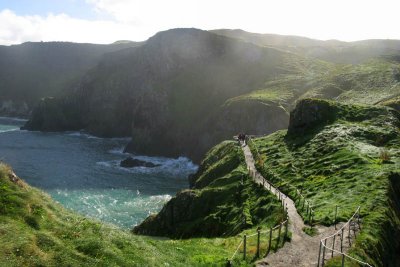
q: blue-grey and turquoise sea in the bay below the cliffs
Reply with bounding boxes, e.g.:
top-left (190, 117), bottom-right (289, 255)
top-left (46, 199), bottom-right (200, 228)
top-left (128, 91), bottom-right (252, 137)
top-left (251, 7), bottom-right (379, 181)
top-left (0, 117), bottom-right (198, 229)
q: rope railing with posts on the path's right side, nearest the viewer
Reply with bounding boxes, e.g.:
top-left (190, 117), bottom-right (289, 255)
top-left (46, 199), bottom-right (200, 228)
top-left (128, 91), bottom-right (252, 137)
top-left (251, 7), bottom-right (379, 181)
top-left (317, 207), bottom-right (372, 267)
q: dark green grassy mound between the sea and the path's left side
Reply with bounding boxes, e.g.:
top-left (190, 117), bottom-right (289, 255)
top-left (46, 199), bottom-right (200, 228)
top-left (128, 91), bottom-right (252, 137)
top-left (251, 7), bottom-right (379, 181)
top-left (133, 141), bottom-right (284, 238)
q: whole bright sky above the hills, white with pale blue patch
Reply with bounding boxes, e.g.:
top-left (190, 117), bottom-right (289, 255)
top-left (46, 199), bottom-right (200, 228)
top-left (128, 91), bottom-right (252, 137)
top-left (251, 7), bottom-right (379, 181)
top-left (0, 0), bottom-right (400, 45)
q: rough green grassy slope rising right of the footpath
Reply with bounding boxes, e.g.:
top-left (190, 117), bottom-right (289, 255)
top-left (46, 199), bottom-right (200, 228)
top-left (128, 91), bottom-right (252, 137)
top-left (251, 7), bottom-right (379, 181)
top-left (253, 100), bottom-right (400, 266)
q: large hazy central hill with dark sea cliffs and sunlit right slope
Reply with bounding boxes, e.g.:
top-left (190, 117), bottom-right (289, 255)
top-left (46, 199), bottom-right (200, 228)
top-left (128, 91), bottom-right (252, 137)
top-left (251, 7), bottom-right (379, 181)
top-left (25, 29), bottom-right (400, 162)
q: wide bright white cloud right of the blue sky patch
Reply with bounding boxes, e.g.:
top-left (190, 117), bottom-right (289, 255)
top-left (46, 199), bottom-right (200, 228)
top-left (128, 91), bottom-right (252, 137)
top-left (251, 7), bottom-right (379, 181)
top-left (86, 0), bottom-right (400, 41)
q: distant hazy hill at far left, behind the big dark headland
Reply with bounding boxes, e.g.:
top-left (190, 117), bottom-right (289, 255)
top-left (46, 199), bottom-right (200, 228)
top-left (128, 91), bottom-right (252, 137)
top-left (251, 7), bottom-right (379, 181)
top-left (0, 42), bottom-right (138, 117)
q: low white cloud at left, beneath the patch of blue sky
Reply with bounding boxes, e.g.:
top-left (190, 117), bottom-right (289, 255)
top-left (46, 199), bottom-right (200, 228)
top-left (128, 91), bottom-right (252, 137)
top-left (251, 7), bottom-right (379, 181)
top-left (0, 10), bottom-right (137, 45)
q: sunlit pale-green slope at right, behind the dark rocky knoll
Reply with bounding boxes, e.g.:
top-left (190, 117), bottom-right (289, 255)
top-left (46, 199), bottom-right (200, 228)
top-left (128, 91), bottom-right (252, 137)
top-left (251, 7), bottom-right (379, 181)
top-left (226, 58), bottom-right (400, 109)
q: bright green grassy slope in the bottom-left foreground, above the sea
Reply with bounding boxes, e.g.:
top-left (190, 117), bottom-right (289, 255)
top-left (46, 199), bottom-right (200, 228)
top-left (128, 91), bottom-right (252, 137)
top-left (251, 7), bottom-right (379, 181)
top-left (0, 164), bottom-right (253, 266)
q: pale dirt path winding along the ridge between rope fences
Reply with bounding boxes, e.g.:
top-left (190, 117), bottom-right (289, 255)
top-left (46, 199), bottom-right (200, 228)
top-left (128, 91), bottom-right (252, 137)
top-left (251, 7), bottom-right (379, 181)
top-left (242, 145), bottom-right (350, 267)
